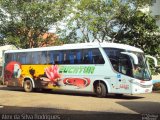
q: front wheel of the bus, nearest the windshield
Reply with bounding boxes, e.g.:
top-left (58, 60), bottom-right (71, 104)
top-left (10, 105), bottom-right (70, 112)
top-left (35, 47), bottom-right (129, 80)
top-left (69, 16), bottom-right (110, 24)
top-left (95, 82), bottom-right (107, 98)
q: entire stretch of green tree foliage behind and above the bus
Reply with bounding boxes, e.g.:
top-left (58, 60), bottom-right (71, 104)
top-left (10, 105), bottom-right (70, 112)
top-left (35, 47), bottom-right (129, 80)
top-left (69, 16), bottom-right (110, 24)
top-left (0, 0), bottom-right (160, 62)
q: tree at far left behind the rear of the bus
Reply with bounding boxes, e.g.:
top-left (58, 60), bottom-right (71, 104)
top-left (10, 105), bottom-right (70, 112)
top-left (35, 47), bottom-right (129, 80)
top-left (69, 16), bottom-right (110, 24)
top-left (0, 0), bottom-right (70, 48)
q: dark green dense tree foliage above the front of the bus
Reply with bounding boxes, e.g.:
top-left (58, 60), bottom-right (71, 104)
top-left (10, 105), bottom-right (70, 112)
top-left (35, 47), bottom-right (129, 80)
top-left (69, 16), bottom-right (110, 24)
top-left (114, 11), bottom-right (160, 55)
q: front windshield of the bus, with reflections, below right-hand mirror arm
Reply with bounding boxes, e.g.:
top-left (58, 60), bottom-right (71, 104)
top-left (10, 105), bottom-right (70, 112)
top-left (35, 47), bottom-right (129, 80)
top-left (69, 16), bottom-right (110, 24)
top-left (133, 53), bottom-right (151, 80)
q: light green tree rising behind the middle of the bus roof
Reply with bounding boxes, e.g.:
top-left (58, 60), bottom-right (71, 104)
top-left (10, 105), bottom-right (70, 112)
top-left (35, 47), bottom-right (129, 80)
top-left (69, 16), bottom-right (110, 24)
top-left (59, 0), bottom-right (122, 42)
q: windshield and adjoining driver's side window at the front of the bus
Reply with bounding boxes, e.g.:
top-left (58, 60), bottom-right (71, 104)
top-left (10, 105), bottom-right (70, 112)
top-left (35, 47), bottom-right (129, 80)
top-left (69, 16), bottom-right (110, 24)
top-left (104, 48), bottom-right (151, 80)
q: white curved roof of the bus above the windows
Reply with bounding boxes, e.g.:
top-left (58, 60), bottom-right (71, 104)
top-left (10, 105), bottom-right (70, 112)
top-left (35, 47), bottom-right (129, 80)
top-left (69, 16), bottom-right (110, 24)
top-left (5, 42), bottom-right (143, 53)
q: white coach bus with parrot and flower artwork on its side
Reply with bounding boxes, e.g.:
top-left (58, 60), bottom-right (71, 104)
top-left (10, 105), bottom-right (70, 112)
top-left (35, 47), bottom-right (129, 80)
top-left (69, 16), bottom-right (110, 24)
top-left (3, 43), bottom-right (153, 97)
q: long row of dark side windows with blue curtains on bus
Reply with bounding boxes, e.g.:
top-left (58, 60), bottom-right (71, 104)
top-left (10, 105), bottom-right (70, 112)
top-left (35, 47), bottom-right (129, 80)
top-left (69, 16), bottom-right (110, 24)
top-left (6, 48), bottom-right (104, 64)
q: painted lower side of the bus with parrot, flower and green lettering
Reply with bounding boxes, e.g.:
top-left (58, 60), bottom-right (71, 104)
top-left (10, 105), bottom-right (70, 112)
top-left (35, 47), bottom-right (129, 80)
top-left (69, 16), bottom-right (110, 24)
top-left (4, 58), bottom-right (130, 93)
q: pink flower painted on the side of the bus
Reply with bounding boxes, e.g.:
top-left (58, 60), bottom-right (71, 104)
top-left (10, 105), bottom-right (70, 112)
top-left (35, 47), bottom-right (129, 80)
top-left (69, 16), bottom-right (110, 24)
top-left (45, 65), bottom-right (60, 83)
